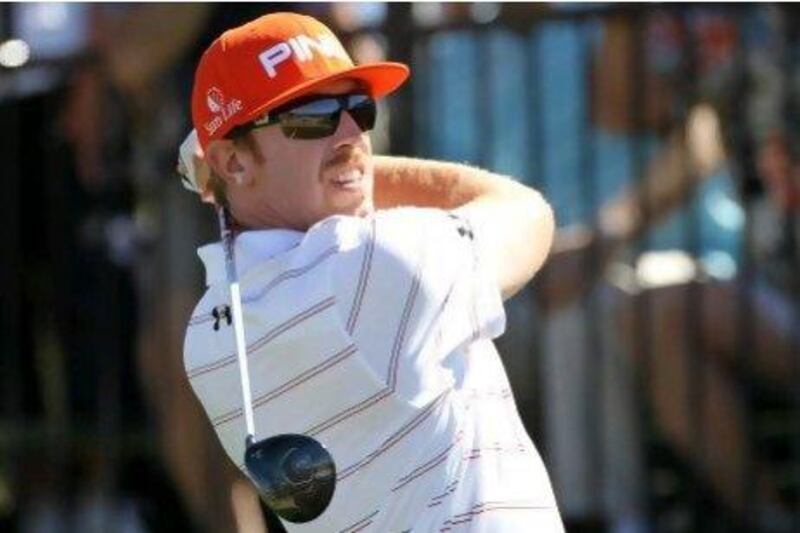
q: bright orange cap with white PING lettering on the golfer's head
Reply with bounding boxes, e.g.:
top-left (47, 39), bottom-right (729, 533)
top-left (192, 13), bottom-right (409, 150)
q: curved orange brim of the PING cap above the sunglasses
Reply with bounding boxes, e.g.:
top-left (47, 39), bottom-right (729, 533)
top-left (228, 61), bottom-right (410, 130)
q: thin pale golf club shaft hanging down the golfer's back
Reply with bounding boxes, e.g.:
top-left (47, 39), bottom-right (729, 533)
top-left (217, 206), bottom-right (256, 442)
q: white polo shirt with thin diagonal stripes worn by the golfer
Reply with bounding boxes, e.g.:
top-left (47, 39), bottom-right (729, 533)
top-left (184, 208), bottom-right (563, 533)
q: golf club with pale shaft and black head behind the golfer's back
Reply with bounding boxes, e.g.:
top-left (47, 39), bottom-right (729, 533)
top-left (217, 206), bottom-right (336, 523)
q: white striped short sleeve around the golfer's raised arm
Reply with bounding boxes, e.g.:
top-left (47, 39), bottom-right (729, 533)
top-left (334, 208), bottom-right (505, 404)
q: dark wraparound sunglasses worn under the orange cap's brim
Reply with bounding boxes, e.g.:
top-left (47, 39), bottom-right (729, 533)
top-left (226, 94), bottom-right (377, 140)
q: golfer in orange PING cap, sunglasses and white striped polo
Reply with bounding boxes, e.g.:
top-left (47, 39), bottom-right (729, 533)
top-left (181, 13), bottom-right (563, 533)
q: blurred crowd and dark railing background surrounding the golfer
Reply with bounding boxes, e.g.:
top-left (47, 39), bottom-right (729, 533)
top-left (0, 2), bottom-right (800, 533)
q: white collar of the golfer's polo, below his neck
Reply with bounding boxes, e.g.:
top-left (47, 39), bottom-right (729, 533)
top-left (197, 229), bottom-right (305, 286)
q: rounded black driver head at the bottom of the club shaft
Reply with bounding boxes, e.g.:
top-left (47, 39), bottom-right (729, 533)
top-left (244, 434), bottom-right (336, 523)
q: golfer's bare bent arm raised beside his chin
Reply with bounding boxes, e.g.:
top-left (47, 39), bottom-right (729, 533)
top-left (375, 156), bottom-right (555, 299)
